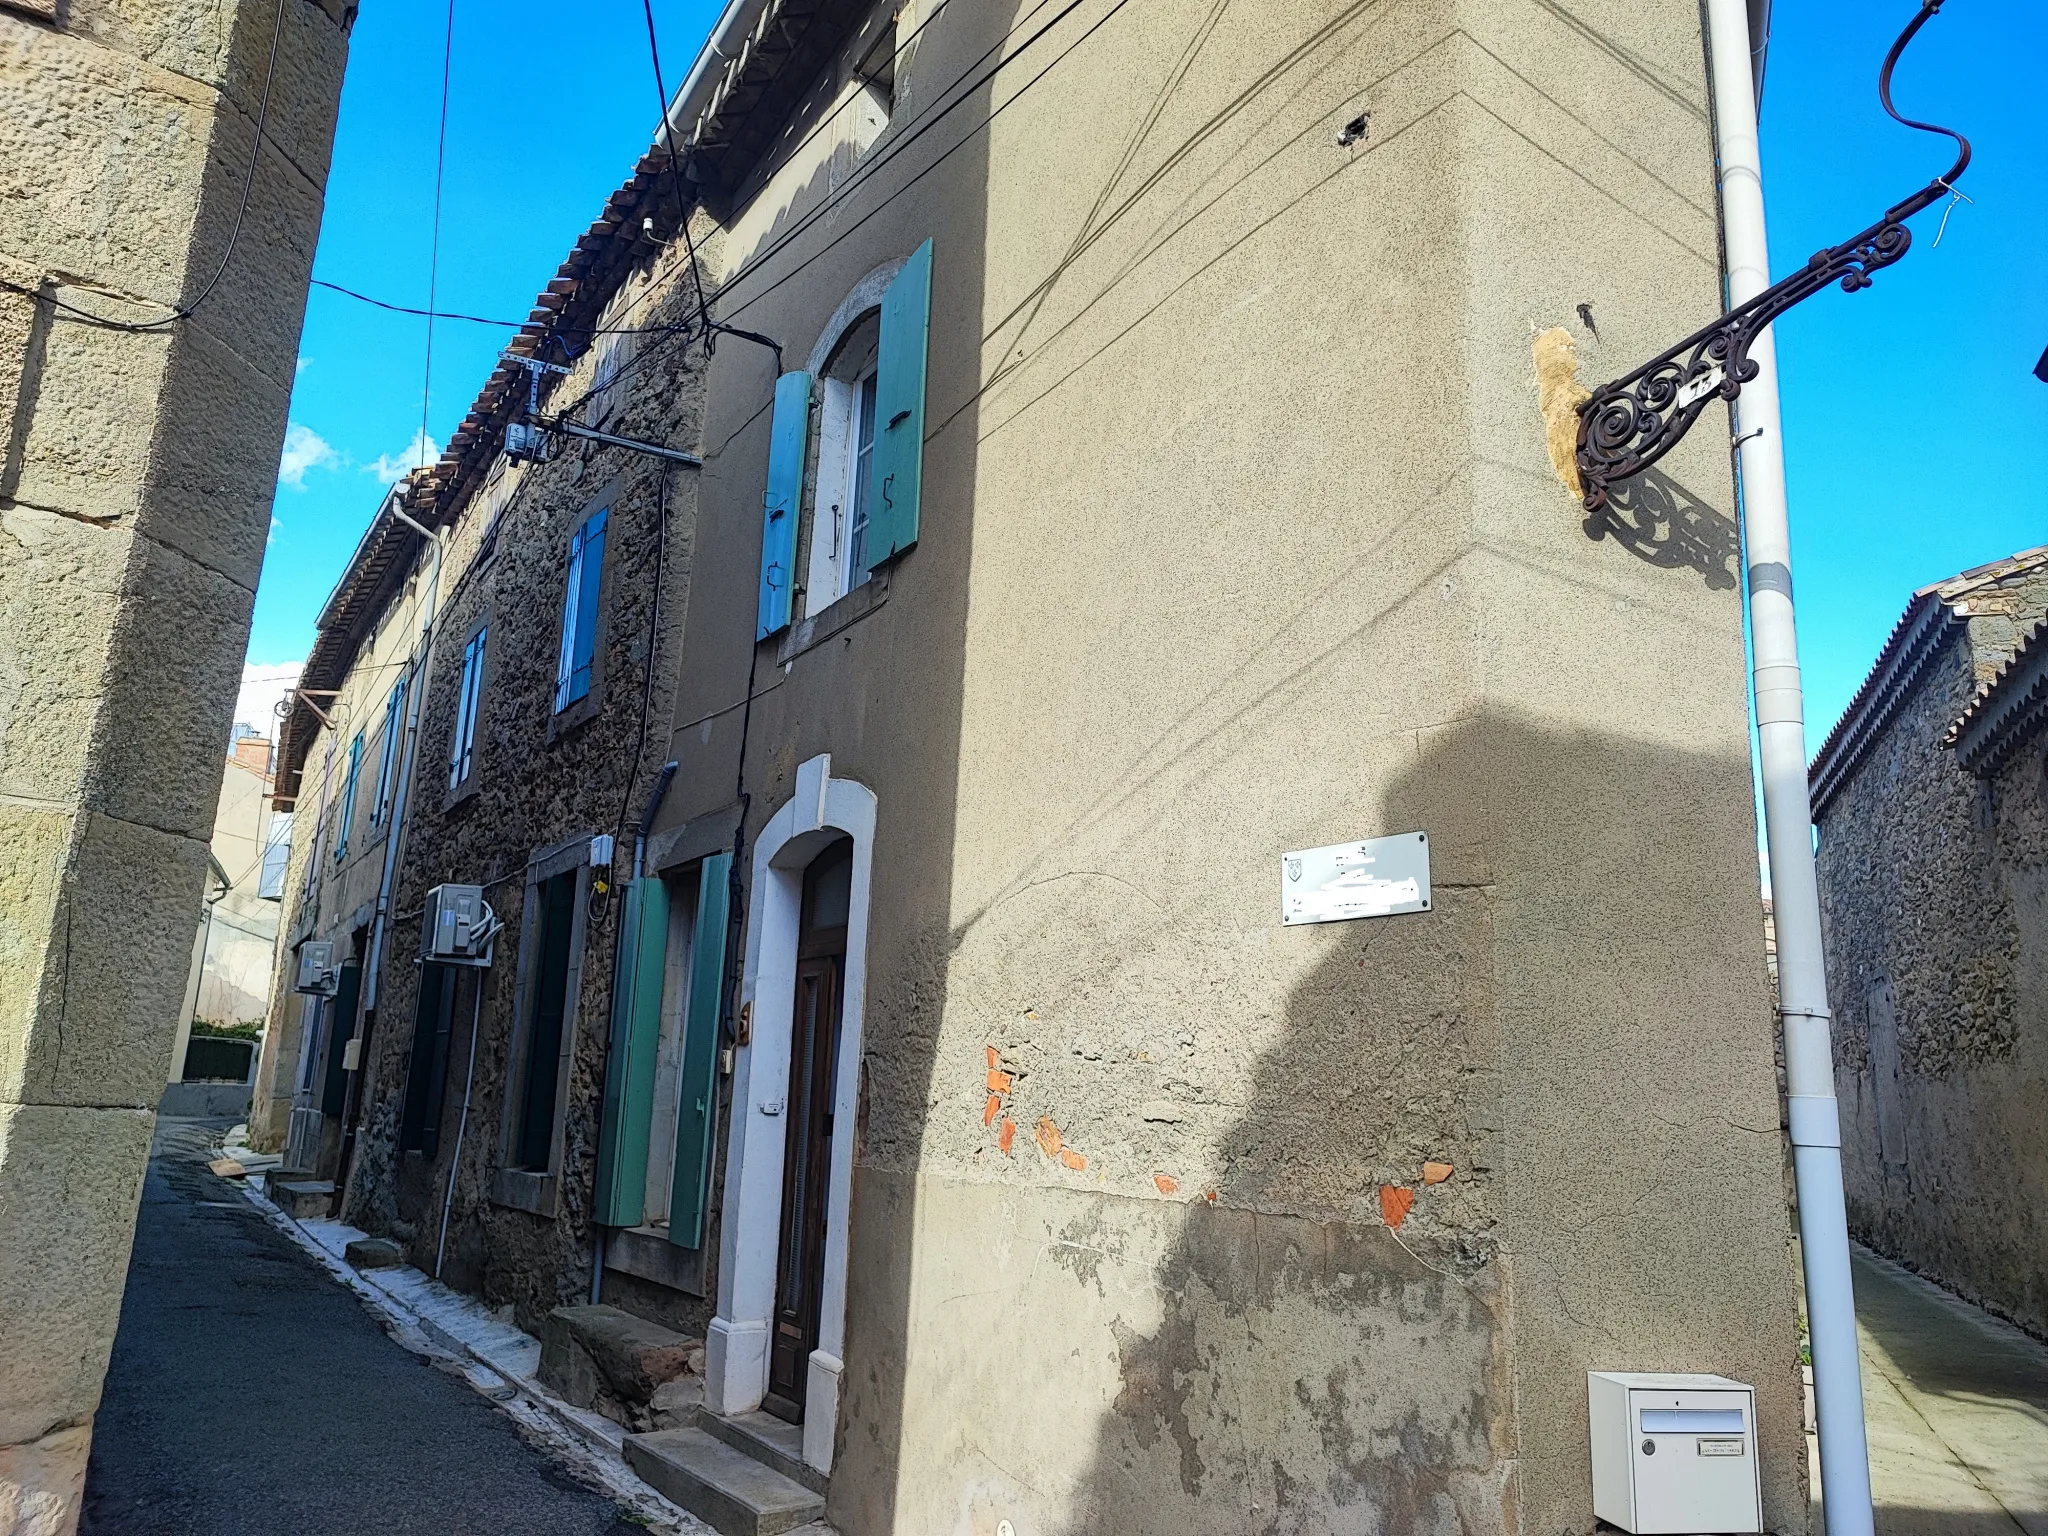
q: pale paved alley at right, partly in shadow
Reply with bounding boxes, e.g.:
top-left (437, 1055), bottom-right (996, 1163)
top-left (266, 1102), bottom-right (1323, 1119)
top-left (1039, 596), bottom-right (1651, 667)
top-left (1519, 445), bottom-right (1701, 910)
top-left (1843, 1249), bottom-right (2048, 1536)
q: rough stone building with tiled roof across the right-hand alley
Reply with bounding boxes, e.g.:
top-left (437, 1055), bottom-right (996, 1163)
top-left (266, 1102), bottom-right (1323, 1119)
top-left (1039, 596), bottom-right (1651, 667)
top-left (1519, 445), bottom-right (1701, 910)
top-left (1812, 549), bottom-right (2048, 1333)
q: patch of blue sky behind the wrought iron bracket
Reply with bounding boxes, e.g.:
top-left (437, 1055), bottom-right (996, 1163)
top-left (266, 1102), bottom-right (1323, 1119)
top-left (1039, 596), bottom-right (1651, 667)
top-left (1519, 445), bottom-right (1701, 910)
top-left (1763, 0), bottom-right (2048, 737)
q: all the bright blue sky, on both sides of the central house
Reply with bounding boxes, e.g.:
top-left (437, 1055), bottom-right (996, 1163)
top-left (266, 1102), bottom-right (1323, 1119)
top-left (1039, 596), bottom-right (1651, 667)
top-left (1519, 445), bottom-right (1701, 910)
top-left (250, 0), bottom-right (2048, 745)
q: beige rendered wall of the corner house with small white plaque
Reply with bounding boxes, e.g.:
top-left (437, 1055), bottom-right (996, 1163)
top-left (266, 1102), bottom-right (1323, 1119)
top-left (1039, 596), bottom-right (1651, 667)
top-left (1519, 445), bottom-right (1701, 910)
top-left (662, 0), bottom-right (1806, 1536)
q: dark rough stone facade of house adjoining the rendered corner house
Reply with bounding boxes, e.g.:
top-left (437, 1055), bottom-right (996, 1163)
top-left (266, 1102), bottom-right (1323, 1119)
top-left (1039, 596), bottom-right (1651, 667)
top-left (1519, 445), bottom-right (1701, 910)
top-left (346, 254), bottom-right (702, 1331)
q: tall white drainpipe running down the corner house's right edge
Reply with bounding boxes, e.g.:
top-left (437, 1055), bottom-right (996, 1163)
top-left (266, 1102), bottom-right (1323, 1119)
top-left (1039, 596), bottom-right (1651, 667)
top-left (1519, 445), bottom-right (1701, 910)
top-left (1706, 0), bottom-right (1874, 1536)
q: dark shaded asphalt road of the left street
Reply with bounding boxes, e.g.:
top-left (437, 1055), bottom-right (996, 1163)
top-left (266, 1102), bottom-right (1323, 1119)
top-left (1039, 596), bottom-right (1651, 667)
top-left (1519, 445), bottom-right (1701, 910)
top-left (80, 1122), bottom-right (643, 1536)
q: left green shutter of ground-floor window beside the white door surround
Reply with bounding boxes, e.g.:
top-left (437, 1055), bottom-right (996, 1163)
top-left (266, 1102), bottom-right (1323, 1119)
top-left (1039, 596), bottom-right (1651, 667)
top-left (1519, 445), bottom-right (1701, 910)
top-left (592, 874), bottom-right (668, 1227)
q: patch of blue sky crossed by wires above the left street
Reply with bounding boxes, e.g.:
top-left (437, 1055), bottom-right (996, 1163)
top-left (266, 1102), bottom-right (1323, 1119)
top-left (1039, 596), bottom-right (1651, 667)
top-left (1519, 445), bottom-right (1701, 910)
top-left (248, 0), bottom-right (721, 664)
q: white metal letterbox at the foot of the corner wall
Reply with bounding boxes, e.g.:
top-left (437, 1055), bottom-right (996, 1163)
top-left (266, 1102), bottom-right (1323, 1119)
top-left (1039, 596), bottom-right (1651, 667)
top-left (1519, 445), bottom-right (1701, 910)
top-left (1585, 1370), bottom-right (1763, 1536)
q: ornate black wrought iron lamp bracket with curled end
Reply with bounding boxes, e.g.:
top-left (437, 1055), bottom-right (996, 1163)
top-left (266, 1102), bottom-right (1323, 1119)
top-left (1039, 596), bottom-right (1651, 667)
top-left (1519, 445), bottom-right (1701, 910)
top-left (1577, 0), bottom-right (1970, 512)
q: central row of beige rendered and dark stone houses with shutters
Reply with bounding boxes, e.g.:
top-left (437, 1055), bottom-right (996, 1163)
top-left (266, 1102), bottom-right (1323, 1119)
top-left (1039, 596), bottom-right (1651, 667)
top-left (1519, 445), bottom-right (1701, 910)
top-left (260, 0), bottom-right (1806, 1536)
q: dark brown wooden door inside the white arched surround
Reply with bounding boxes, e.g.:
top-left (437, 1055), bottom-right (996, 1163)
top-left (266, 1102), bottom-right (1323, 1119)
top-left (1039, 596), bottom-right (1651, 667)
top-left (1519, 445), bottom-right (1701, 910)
top-left (764, 958), bottom-right (846, 1423)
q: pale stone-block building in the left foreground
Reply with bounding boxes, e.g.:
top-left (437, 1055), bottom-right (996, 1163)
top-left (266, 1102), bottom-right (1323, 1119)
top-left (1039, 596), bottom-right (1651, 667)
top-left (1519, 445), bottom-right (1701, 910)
top-left (0, 0), bottom-right (354, 1532)
